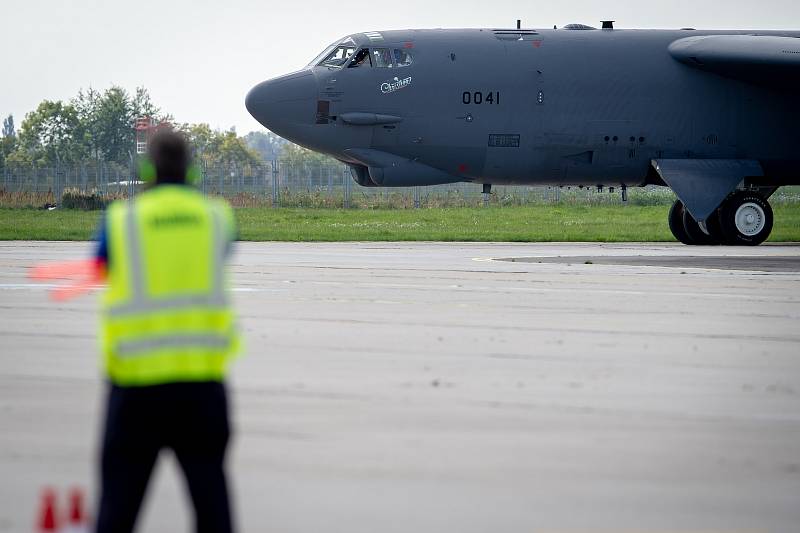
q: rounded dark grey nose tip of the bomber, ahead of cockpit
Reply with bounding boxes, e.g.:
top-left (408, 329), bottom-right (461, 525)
top-left (244, 71), bottom-right (317, 133)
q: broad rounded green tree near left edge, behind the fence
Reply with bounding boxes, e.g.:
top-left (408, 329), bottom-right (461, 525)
top-left (8, 100), bottom-right (88, 165)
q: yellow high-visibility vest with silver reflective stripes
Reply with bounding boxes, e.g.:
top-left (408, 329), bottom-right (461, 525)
top-left (101, 185), bottom-right (240, 386)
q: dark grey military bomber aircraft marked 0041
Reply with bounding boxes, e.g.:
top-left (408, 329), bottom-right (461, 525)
top-left (245, 21), bottom-right (800, 245)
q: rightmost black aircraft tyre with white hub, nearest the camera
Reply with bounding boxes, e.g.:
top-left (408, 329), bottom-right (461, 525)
top-left (719, 191), bottom-right (773, 246)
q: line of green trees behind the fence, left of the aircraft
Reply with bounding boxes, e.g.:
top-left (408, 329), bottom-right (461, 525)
top-left (0, 86), bottom-right (328, 169)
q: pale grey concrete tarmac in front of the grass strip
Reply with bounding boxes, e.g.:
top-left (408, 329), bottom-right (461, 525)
top-left (0, 242), bottom-right (800, 533)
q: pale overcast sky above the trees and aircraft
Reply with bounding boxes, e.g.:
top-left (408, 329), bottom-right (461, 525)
top-left (0, 0), bottom-right (800, 134)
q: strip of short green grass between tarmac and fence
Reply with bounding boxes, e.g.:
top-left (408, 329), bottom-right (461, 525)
top-left (0, 204), bottom-right (800, 242)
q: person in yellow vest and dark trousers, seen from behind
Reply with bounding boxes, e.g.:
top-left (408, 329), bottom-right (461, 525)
top-left (97, 131), bottom-right (239, 533)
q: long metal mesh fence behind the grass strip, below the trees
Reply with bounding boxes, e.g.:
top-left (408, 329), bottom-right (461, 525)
top-left (0, 161), bottom-right (800, 208)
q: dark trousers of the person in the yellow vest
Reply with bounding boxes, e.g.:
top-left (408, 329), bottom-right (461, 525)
top-left (97, 382), bottom-right (233, 533)
